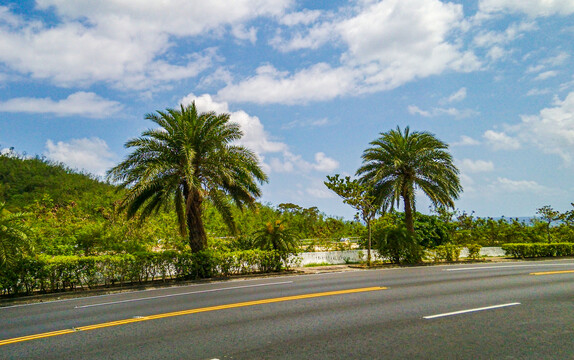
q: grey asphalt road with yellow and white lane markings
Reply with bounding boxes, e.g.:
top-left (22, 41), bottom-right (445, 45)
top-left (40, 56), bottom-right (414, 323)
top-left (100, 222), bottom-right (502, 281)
top-left (0, 259), bottom-right (574, 359)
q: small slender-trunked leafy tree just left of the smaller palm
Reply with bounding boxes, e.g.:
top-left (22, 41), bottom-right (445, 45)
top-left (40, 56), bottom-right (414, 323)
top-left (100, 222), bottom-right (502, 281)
top-left (325, 174), bottom-right (381, 266)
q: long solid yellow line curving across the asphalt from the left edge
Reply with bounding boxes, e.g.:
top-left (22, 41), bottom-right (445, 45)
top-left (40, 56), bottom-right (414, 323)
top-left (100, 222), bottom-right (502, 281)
top-left (0, 287), bottom-right (387, 346)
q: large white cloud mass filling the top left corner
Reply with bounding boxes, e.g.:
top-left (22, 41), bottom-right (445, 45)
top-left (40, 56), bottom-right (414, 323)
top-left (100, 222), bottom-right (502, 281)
top-left (0, 0), bottom-right (292, 89)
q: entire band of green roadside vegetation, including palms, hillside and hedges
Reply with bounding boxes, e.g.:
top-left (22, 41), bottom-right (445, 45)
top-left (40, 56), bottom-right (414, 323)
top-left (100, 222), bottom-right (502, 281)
top-left (0, 111), bottom-right (574, 295)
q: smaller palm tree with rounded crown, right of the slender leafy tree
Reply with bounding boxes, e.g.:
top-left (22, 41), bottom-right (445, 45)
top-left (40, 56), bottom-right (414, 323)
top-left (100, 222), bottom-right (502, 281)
top-left (357, 126), bottom-right (462, 234)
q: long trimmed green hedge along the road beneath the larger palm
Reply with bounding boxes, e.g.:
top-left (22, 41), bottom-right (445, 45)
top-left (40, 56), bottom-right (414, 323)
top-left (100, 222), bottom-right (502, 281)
top-left (0, 250), bottom-right (289, 295)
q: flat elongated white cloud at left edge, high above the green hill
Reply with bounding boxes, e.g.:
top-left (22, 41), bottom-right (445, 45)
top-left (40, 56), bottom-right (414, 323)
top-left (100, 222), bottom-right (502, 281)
top-left (0, 91), bottom-right (123, 118)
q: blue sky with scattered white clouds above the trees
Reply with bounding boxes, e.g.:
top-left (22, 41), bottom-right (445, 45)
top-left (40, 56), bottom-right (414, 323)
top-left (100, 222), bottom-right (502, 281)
top-left (0, 0), bottom-right (574, 219)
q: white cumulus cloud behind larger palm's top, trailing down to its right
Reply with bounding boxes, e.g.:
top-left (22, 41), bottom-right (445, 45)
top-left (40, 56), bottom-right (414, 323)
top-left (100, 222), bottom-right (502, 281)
top-left (180, 94), bottom-right (339, 173)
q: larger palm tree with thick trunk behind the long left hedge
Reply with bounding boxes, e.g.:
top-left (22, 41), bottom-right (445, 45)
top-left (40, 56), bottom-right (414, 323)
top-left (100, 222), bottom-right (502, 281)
top-left (108, 103), bottom-right (267, 252)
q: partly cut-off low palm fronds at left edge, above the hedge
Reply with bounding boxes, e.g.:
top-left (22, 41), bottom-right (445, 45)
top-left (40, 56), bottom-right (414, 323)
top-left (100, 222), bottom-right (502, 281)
top-left (0, 203), bottom-right (33, 266)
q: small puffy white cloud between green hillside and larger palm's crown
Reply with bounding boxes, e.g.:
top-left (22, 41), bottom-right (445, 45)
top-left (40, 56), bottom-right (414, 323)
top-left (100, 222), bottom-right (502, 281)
top-left (44, 138), bottom-right (116, 177)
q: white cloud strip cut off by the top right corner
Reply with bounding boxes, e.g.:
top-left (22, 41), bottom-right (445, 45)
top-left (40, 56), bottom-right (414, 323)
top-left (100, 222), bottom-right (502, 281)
top-left (479, 0), bottom-right (574, 17)
